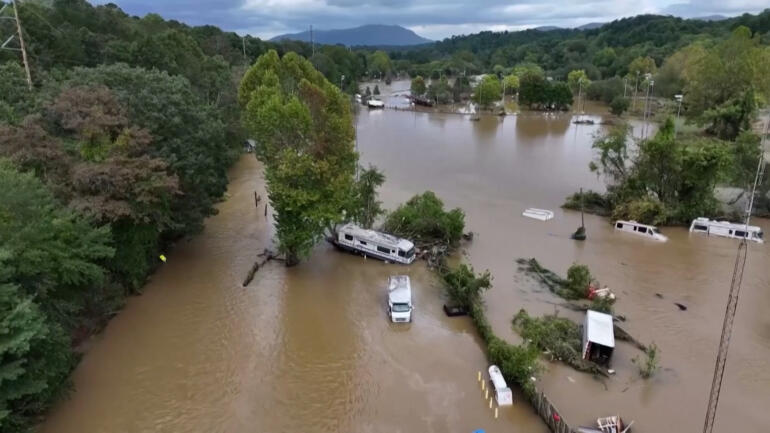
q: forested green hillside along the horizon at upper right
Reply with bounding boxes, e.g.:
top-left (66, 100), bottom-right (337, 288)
top-left (390, 10), bottom-right (770, 80)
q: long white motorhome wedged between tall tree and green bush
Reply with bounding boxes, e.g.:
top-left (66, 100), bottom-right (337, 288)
top-left (334, 223), bottom-right (415, 265)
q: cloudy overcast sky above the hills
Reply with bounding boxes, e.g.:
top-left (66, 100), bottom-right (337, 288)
top-left (92, 0), bottom-right (770, 39)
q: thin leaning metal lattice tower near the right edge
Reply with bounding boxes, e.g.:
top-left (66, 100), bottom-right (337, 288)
top-left (703, 120), bottom-right (770, 433)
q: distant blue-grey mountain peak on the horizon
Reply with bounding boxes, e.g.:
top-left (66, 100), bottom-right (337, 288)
top-left (271, 24), bottom-right (433, 46)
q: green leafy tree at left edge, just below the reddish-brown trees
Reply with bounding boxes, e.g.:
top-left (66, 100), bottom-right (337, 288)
top-left (0, 162), bottom-right (114, 326)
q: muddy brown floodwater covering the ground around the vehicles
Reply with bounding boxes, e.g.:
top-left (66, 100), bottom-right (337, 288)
top-left (41, 87), bottom-right (770, 433)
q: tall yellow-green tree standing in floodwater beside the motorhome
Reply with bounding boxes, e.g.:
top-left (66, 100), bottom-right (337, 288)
top-left (239, 50), bottom-right (357, 266)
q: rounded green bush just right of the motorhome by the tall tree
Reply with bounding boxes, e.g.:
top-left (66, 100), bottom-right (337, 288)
top-left (383, 191), bottom-right (465, 246)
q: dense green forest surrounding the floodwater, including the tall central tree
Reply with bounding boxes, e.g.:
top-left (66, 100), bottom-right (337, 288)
top-left (0, 0), bottom-right (770, 432)
